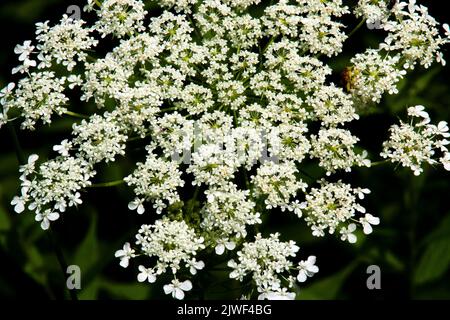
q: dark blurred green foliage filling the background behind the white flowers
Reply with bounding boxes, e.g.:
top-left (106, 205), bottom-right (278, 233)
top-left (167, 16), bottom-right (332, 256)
top-left (0, 0), bottom-right (450, 299)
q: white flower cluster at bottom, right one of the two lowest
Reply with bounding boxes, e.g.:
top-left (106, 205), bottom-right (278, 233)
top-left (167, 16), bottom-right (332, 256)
top-left (228, 233), bottom-right (319, 300)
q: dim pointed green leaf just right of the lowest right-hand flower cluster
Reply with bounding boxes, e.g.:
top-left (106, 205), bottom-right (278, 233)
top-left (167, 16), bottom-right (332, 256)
top-left (297, 261), bottom-right (359, 300)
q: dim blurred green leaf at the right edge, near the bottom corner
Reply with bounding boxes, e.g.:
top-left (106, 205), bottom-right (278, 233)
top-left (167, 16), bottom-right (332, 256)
top-left (414, 237), bottom-right (450, 285)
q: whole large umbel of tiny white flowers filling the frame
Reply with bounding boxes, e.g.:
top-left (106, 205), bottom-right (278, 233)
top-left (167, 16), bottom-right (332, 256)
top-left (0, 0), bottom-right (450, 299)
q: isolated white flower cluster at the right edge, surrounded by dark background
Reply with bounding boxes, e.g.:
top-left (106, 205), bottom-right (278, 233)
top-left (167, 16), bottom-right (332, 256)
top-left (381, 105), bottom-right (450, 176)
